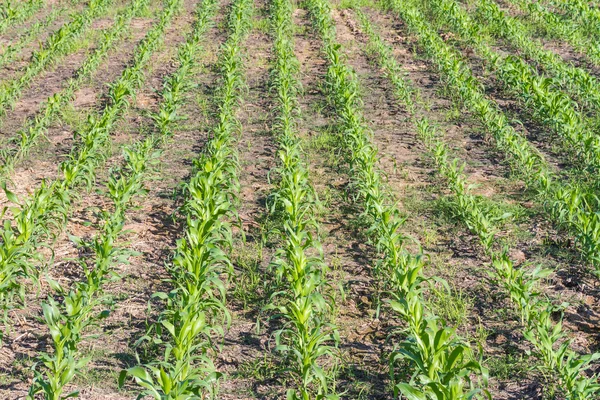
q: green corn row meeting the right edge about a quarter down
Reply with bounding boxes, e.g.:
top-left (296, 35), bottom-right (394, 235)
top-left (476, 0), bottom-right (600, 117)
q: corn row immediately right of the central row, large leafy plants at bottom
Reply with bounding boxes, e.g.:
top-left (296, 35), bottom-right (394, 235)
top-left (306, 0), bottom-right (489, 400)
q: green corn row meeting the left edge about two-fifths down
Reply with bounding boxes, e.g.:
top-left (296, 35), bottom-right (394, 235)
top-left (0, 0), bottom-right (149, 175)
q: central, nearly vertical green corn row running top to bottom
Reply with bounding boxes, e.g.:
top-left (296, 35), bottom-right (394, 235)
top-left (267, 0), bottom-right (339, 400)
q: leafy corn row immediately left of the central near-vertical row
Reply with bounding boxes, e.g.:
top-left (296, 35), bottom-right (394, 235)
top-left (119, 0), bottom-right (253, 400)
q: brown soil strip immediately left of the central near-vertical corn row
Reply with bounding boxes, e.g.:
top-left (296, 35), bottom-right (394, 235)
top-left (216, 1), bottom-right (282, 400)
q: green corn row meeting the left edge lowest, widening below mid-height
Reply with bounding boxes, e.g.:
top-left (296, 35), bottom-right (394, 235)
top-left (0, 0), bottom-right (181, 338)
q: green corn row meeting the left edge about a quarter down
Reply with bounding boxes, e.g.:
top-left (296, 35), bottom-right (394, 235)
top-left (0, 0), bottom-right (114, 117)
